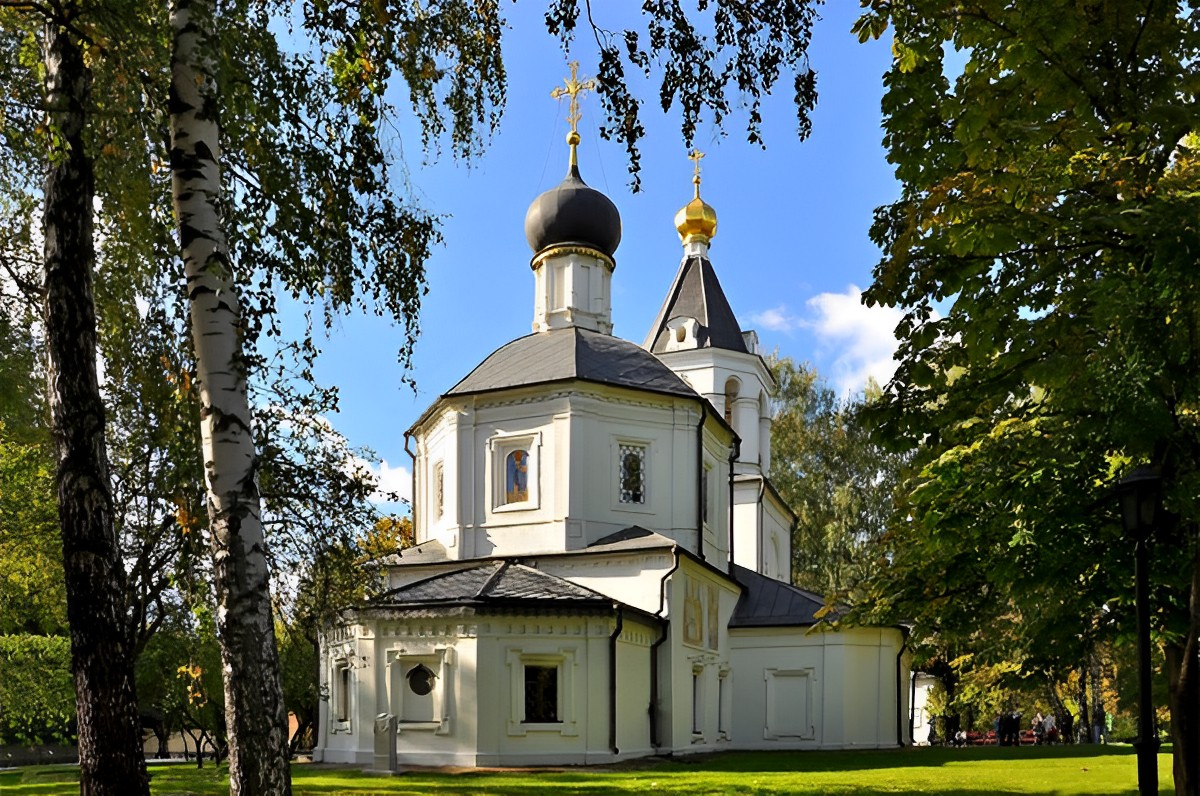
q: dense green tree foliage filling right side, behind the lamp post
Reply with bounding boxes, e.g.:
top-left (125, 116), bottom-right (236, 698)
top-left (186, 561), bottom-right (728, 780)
top-left (857, 0), bottom-right (1200, 792)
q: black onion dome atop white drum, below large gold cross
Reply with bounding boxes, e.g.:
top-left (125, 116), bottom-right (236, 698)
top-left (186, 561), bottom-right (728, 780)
top-left (526, 163), bottom-right (620, 257)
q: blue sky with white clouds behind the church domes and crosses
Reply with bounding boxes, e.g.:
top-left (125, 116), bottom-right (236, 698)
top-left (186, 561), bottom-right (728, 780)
top-left (297, 2), bottom-right (899, 504)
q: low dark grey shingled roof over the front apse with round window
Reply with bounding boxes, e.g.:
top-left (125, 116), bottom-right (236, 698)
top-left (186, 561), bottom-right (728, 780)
top-left (371, 559), bottom-right (613, 608)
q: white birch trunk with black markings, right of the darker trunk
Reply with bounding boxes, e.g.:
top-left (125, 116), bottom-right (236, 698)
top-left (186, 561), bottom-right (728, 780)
top-left (170, 0), bottom-right (290, 796)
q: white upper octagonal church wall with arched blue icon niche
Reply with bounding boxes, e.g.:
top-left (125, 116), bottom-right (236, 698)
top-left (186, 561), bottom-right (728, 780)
top-left (415, 384), bottom-right (731, 558)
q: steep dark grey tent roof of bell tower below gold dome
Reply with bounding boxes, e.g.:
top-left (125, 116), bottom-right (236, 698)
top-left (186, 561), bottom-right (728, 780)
top-left (646, 257), bottom-right (749, 354)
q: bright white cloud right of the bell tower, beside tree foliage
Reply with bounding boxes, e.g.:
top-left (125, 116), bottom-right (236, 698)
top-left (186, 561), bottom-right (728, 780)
top-left (803, 285), bottom-right (902, 395)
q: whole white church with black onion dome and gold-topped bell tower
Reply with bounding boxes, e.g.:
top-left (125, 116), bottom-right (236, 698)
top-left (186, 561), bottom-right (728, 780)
top-left (314, 78), bottom-right (911, 770)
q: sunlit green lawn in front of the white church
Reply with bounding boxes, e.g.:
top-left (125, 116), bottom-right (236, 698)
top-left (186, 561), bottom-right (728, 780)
top-left (0, 746), bottom-right (1174, 796)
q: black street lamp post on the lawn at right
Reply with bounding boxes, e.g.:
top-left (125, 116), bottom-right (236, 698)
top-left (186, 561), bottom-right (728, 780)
top-left (1117, 465), bottom-right (1162, 796)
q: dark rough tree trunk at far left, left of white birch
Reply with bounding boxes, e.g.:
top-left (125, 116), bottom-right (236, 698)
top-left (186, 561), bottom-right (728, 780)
top-left (42, 8), bottom-right (150, 796)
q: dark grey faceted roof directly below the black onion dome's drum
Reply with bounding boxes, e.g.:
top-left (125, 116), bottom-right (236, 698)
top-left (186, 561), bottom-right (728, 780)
top-left (446, 327), bottom-right (696, 397)
